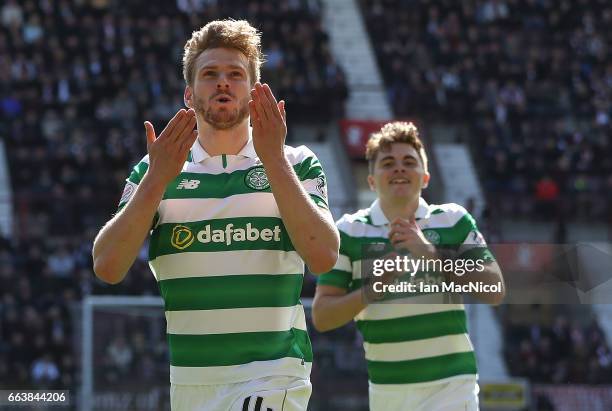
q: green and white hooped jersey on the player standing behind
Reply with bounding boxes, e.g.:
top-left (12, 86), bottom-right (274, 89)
top-left (318, 199), bottom-right (493, 387)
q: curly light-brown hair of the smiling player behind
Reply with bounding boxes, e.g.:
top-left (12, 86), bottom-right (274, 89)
top-left (366, 121), bottom-right (428, 173)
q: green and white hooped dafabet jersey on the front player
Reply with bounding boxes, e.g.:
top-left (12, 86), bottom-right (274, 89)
top-left (119, 140), bottom-right (327, 385)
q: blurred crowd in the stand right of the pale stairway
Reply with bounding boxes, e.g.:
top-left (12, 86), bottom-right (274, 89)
top-left (361, 0), bottom-right (612, 222)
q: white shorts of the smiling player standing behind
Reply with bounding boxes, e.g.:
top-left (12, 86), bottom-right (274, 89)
top-left (369, 378), bottom-right (479, 411)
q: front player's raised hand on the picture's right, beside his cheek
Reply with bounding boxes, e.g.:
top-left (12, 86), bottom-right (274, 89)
top-left (249, 83), bottom-right (287, 164)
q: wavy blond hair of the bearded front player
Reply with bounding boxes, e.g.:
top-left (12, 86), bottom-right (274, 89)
top-left (183, 19), bottom-right (264, 86)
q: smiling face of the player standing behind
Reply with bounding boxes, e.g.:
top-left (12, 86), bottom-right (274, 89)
top-left (368, 143), bottom-right (429, 203)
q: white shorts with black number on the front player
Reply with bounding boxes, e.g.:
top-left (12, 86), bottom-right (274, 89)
top-left (170, 377), bottom-right (312, 411)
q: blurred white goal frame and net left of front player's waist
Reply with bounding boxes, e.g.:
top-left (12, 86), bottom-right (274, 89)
top-left (79, 296), bottom-right (170, 411)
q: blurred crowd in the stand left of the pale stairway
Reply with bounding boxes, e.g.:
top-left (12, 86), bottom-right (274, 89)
top-left (0, 0), bottom-right (347, 388)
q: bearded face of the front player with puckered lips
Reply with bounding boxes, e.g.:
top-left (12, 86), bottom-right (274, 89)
top-left (185, 48), bottom-right (251, 130)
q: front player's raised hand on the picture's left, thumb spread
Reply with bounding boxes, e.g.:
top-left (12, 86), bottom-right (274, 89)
top-left (144, 109), bottom-right (198, 185)
